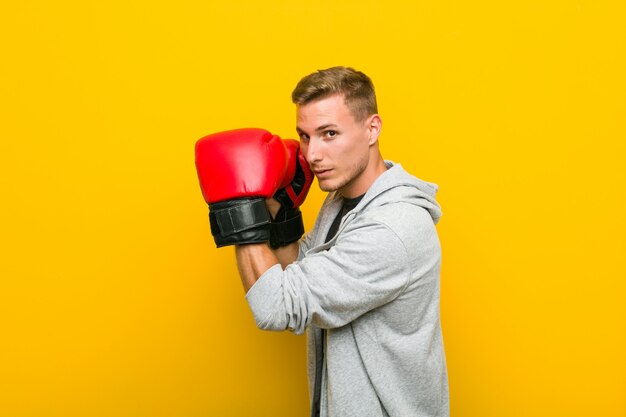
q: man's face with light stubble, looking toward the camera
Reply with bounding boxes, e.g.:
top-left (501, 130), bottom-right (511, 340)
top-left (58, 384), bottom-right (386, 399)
top-left (296, 95), bottom-right (371, 198)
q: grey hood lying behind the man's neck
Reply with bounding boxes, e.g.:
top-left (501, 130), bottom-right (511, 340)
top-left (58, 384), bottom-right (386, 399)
top-left (333, 161), bottom-right (441, 224)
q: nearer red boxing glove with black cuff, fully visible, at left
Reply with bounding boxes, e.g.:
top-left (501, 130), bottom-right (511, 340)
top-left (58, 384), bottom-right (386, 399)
top-left (195, 128), bottom-right (287, 248)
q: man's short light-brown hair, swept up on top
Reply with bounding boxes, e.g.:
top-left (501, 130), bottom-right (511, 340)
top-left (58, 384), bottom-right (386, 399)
top-left (291, 66), bottom-right (378, 121)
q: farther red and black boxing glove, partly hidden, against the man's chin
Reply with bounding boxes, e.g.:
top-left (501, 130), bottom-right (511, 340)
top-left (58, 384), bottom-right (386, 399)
top-left (270, 139), bottom-right (314, 249)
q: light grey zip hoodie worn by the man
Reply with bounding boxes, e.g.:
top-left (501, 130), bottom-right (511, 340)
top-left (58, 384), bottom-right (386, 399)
top-left (246, 161), bottom-right (450, 417)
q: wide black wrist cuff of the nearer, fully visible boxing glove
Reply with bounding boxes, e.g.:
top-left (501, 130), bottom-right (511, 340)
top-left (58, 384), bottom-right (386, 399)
top-left (209, 198), bottom-right (271, 248)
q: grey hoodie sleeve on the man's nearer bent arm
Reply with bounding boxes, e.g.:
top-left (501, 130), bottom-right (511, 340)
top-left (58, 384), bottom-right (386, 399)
top-left (246, 216), bottom-right (411, 334)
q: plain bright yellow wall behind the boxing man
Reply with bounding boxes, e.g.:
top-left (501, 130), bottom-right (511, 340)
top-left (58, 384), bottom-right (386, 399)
top-left (0, 0), bottom-right (626, 417)
